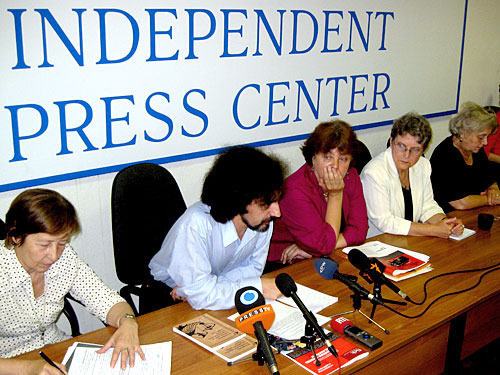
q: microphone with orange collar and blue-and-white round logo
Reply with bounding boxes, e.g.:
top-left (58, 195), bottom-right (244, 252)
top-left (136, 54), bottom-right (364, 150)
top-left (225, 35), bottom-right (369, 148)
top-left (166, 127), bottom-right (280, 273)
top-left (234, 286), bottom-right (280, 375)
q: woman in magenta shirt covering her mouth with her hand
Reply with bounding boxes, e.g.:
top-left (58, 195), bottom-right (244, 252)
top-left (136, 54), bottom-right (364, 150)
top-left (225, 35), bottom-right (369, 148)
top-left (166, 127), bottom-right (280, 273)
top-left (266, 120), bottom-right (368, 271)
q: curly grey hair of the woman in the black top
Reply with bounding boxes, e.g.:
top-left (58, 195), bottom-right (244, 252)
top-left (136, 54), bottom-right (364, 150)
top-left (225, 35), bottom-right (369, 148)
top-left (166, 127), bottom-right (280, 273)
top-left (449, 102), bottom-right (498, 137)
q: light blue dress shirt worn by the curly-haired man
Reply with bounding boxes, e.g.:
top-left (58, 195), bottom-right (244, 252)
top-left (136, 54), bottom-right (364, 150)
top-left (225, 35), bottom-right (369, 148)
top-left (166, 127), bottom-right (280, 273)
top-left (149, 202), bottom-right (273, 310)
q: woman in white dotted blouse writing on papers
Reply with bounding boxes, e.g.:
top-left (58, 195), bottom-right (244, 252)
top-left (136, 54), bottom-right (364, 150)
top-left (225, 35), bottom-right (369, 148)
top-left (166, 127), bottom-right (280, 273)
top-left (0, 189), bottom-right (145, 374)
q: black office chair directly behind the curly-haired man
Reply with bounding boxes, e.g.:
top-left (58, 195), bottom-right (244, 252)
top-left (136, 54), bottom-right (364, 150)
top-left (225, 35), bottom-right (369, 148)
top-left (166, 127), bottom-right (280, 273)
top-left (111, 163), bottom-right (186, 315)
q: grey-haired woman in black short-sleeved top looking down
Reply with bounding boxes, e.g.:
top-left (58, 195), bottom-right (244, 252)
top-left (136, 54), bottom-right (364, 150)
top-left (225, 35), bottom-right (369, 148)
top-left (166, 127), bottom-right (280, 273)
top-left (431, 102), bottom-right (500, 212)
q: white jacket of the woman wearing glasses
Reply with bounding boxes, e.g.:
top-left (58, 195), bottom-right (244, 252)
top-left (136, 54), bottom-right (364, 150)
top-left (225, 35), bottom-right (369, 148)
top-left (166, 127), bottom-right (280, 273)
top-left (361, 147), bottom-right (444, 237)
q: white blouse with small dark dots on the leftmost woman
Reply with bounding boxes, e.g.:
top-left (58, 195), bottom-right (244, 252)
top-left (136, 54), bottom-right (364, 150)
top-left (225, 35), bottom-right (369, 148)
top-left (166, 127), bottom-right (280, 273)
top-left (0, 241), bottom-right (124, 358)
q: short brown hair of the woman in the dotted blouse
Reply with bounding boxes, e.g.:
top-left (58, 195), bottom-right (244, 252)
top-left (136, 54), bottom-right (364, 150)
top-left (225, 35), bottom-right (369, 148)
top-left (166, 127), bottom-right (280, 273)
top-left (5, 189), bottom-right (80, 248)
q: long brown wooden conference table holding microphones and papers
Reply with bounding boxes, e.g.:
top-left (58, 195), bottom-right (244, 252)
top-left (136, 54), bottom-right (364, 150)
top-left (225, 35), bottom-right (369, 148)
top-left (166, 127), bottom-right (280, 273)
top-left (18, 207), bottom-right (500, 375)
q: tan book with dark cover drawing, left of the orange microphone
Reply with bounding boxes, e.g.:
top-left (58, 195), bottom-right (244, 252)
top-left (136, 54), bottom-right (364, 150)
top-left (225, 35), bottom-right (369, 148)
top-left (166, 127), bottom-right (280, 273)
top-left (173, 313), bottom-right (257, 362)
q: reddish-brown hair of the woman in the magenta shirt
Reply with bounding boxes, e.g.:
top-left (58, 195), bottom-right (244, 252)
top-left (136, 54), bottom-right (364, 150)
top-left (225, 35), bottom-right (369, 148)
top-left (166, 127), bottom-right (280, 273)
top-left (300, 120), bottom-right (359, 165)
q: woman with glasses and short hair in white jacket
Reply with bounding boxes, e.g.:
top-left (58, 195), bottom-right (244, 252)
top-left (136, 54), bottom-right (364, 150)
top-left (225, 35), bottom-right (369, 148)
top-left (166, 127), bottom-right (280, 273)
top-left (361, 113), bottom-right (463, 238)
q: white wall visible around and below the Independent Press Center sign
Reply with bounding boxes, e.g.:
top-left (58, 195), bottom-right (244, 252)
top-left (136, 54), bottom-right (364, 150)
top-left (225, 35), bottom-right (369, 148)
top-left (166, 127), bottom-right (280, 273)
top-left (0, 0), bottom-right (500, 332)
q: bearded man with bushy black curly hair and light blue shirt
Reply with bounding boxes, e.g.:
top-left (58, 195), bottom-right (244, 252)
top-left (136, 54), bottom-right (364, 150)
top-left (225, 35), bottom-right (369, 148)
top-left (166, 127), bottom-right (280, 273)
top-left (149, 147), bottom-right (284, 310)
